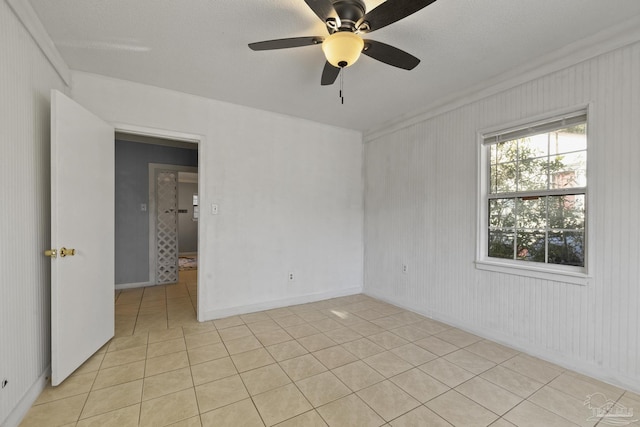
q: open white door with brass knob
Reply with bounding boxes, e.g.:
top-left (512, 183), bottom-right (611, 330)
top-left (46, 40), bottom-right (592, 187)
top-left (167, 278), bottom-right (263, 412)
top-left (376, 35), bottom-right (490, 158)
top-left (51, 90), bottom-right (115, 385)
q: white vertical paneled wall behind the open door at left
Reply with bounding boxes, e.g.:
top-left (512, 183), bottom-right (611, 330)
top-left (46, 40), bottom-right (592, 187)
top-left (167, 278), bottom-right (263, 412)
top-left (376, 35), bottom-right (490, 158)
top-left (0, 1), bottom-right (65, 424)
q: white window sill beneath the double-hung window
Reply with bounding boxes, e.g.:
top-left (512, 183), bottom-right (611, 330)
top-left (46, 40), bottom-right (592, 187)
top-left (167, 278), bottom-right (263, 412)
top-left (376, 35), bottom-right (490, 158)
top-left (475, 259), bottom-right (591, 286)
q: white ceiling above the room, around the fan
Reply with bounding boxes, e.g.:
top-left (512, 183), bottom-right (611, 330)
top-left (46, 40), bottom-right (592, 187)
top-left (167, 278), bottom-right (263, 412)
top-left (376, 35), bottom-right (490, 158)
top-left (30, 0), bottom-right (640, 131)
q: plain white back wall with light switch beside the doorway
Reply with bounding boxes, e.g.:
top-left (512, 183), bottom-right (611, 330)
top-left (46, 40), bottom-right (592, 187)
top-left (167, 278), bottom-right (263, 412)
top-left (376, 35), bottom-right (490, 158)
top-left (72, 72), bottom-right (363, 320)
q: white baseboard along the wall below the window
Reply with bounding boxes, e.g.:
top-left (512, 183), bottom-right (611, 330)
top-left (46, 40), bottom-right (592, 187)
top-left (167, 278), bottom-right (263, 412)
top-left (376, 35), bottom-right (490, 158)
top-left (363, 292), bottom-right (640, 393)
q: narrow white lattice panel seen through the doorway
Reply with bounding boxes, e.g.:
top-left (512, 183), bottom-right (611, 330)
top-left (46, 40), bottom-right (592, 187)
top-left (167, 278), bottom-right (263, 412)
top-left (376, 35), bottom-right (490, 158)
top-left (156, 170), bottom-right (178, 284)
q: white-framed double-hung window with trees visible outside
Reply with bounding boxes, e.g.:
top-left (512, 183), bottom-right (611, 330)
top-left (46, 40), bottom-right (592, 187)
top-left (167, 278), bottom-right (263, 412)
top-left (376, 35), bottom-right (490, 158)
top-left (480, 111), bottom-right (587, 278)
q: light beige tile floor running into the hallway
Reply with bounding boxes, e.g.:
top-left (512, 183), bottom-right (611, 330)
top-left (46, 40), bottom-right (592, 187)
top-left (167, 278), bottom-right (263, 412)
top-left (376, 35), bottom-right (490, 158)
top-left (21, 271), bottom-right (640, 427)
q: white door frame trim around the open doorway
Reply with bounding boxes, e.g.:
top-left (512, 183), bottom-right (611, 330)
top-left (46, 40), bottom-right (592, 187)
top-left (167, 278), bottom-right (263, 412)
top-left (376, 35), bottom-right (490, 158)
top-left (111, 122), bottom-right (207, 321)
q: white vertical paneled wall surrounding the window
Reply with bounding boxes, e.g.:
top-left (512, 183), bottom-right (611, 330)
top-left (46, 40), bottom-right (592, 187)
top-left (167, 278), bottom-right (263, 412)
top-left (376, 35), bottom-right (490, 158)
top-left (365, 43), bottom-right (640, 390)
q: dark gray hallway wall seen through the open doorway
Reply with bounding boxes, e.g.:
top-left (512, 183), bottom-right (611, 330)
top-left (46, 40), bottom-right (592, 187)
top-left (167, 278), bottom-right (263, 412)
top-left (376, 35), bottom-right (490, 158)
top-left (115, 140), bottom-right (198, 285)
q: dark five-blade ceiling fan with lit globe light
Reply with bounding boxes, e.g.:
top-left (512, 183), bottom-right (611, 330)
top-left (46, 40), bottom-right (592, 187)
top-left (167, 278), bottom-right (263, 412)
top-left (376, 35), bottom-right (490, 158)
top-left (249, 0), bottom-right (436, 85)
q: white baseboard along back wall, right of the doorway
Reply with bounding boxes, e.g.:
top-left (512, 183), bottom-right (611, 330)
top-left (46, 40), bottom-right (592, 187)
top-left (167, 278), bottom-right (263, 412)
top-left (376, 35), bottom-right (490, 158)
top-left (198, 287), bottom-right (362, 322)
